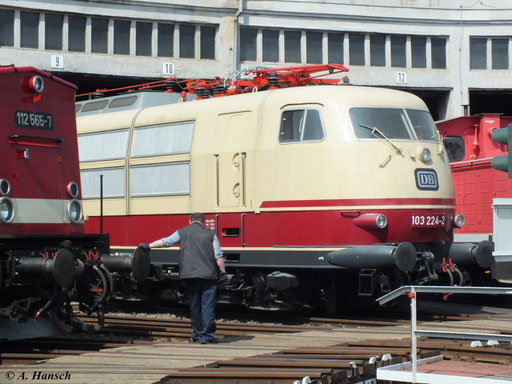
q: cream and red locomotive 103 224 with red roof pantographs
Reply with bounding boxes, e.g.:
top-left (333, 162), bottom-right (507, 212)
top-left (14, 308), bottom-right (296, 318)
top-left (77, 65), bottom-right (491, 312)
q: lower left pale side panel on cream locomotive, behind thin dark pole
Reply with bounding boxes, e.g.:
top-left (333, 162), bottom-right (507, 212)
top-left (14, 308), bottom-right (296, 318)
top-left (80, 168), bottom-right (125, 199)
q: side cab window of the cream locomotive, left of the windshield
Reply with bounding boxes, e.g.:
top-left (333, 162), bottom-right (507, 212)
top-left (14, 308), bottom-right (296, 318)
top-left (279, 109), bottom-right (324, 143)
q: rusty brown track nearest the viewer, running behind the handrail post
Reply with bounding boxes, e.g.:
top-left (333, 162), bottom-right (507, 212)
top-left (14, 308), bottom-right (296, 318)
top-left (160, 339), bottom-right (512, 384)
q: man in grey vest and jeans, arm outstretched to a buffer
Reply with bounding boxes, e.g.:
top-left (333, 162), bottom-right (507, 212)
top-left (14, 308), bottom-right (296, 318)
top-left (140, 213), bottom-right (226, 344)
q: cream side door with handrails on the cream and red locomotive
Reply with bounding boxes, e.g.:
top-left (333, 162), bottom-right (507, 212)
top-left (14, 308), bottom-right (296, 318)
top-left (214, 111), bottom-right (255, 208)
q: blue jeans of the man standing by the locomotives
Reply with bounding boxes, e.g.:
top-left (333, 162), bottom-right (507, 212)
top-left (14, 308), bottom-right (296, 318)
top-left (184, 279), bottom-right (217, 341)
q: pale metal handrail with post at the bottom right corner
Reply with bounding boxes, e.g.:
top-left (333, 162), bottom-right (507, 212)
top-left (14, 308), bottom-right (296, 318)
top-left (377, 286), bottom-right (512, 384)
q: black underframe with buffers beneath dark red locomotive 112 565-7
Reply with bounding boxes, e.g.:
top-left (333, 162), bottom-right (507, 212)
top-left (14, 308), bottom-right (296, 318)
top-left (0, 234), bottom-right (150, 338)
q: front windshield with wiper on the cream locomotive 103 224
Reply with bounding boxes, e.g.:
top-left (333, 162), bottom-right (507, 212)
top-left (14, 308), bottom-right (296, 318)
top-left (350, 107), bottom-right (438, 141)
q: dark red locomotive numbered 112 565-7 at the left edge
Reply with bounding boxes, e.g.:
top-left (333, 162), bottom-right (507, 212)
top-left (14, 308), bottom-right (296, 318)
top-left (0, 65), bottom-right (148, 339)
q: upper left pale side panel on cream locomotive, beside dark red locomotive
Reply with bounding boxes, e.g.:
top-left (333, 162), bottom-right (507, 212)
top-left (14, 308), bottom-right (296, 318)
top-left (78, 129), bottom-right (129, 162)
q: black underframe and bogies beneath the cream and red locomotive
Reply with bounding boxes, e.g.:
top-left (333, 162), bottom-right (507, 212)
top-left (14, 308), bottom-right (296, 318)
top-left (114, 244), bottom-right (494, 313)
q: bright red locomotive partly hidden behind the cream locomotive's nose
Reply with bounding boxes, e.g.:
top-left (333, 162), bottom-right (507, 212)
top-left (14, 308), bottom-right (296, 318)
top-left (437, 113), bottom-right (512, 279)
